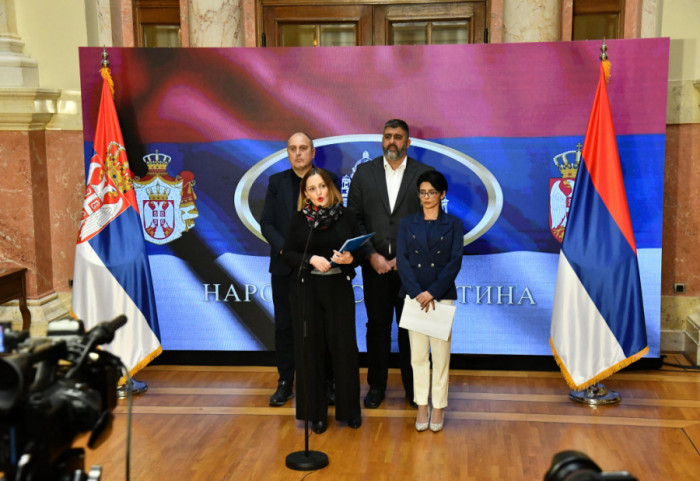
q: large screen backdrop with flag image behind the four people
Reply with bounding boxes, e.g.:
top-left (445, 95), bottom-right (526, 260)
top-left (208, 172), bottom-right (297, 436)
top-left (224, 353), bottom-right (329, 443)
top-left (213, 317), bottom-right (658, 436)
top-left (80, 39), bottom-right (669, 357)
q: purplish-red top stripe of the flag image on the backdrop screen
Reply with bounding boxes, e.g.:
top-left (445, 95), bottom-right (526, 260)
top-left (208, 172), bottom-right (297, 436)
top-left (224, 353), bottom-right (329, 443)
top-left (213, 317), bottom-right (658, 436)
top-left (80, 38), bottom-right (669, 143)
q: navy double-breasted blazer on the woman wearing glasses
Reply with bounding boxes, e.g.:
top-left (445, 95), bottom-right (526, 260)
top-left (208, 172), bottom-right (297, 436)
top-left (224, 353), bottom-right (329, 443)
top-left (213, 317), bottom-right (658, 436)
top-left (396, 209), bottom-right (464, 301)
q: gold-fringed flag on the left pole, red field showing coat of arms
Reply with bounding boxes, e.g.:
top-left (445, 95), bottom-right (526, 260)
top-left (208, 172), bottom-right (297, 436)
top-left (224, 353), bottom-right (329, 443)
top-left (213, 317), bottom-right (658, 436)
top-left (72, 68), bottom-right (162, 375)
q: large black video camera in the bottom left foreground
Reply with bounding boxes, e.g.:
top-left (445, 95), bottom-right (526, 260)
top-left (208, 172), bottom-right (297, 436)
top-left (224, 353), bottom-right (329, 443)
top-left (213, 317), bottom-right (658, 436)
top-left (0, 315), bottom-right (126, 481)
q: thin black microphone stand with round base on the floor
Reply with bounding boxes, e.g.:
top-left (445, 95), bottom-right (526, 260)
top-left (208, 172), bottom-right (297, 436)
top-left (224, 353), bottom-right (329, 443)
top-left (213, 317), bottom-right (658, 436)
top-left (285, 226), bottom-right (328, 471)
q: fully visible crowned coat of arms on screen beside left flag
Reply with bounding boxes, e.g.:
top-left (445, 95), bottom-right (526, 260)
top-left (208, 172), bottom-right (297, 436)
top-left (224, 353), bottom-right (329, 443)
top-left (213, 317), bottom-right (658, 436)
top-left (134, 150), bottom-right (199, 244)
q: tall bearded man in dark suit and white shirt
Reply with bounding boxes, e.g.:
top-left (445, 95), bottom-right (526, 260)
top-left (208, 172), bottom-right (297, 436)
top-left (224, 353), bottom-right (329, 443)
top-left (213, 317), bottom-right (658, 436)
top-left (348, 119), bottom-right (433, 409)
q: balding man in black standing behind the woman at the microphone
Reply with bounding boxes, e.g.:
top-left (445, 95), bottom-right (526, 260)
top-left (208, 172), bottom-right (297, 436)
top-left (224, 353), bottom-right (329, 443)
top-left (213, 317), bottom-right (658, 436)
top-left (260, 132), bottom-right (337, 406)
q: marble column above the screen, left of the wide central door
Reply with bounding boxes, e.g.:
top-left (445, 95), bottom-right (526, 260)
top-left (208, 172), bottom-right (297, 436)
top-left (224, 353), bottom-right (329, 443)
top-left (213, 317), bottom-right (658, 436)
top-left (188, 0), bottom-right (245, 47)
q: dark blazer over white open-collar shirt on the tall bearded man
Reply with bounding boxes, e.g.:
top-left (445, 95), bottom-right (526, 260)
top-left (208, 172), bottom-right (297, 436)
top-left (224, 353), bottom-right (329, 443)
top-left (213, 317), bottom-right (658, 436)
top-left (348, 157), bottom-right (433, 259)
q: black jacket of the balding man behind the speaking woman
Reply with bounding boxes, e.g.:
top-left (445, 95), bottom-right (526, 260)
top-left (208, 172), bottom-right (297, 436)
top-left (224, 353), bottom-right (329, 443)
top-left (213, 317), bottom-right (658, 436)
top-left (260, 169), bottom-right (338, 275)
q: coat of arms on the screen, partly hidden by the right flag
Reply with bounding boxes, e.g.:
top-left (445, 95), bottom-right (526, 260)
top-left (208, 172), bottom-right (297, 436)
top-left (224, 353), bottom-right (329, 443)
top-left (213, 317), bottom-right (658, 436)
top-left (549, 144), bottom-right (581, 242)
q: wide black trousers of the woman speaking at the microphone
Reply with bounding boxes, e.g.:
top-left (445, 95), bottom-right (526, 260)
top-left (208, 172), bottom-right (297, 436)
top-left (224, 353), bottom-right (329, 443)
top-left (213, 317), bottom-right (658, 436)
top-left (290, 273), bottom-right (360, 422)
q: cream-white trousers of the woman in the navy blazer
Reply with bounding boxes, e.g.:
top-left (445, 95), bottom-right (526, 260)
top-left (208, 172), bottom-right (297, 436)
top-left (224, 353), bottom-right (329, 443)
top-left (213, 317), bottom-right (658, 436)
top-left (408, 299), bottom-right (454, 409)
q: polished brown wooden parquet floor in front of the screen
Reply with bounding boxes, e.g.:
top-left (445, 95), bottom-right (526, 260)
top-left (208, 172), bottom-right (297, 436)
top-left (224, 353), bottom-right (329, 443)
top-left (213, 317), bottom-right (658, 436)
top-left (76, 355), bottom-right (700, 481)
